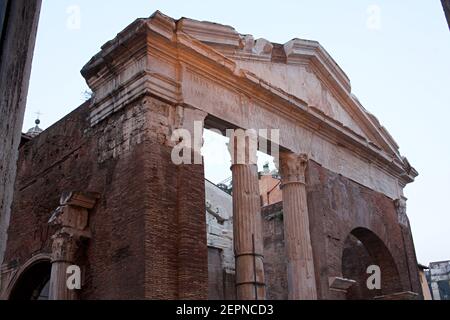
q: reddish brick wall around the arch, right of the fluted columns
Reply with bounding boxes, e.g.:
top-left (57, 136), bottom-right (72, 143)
top-left (307, 161), bottom-right (420, 298)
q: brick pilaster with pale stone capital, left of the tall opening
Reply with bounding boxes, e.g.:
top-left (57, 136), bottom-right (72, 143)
top-left (176, 106), bottom-right (208, 300)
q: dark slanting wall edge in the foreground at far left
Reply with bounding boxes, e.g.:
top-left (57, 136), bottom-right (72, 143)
top-left (0, 0), bottom-right (41, 283)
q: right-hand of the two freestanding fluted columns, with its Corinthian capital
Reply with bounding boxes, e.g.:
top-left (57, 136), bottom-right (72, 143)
top-left (280, 152), bottom-right (317, 300)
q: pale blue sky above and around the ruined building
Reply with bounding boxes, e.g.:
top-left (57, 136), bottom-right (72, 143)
top-left (24, 0), bottom-right (450, 264)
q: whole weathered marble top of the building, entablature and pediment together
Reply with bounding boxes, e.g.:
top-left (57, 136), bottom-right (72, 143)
top-left (82, 12), bottom-right (417, 199)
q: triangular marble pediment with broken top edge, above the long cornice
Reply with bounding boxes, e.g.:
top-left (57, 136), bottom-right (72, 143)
top-left (178, 18), bottom-right (401, 160)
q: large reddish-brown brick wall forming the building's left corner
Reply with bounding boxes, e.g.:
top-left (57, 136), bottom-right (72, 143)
top-left (0, 97), bottom-right (208, 299)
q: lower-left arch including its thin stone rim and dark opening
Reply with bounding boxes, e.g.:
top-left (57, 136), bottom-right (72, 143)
top-left (6, 254), bottom-right (51, 300)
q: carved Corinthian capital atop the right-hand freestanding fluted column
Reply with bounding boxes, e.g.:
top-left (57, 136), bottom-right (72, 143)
top-left (279, 152), bottom-right (308, 186)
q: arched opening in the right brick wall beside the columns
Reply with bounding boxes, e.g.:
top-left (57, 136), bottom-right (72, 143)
top-left (342, 228), bottom-right (402, 300)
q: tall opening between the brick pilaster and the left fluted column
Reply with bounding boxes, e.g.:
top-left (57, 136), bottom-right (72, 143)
top-left (202, 122), bottom-right (281, 300)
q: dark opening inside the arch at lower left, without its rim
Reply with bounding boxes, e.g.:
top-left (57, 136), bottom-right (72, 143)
top-left (9, 260), bottom-right (51, 301)
